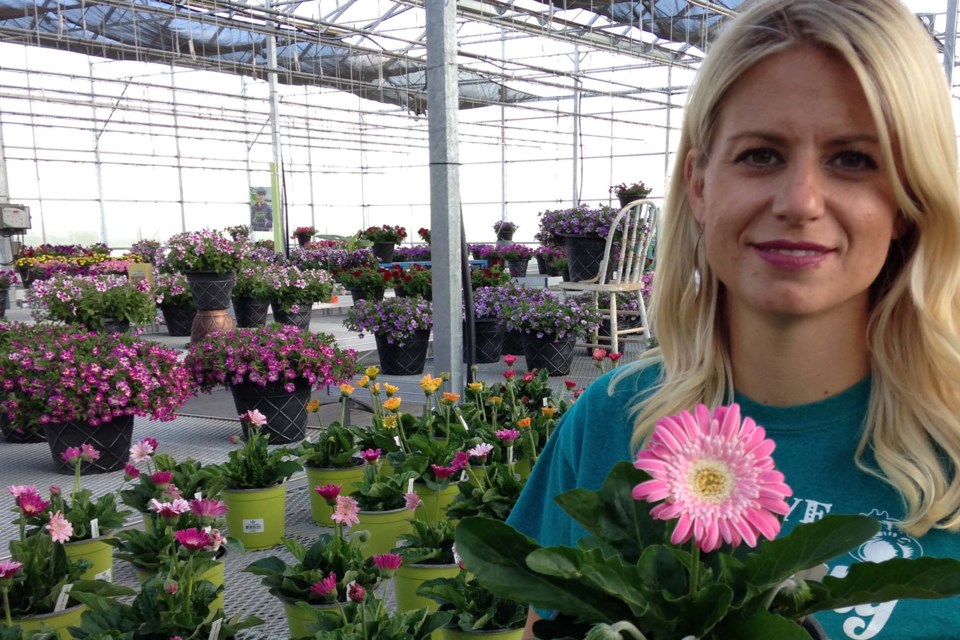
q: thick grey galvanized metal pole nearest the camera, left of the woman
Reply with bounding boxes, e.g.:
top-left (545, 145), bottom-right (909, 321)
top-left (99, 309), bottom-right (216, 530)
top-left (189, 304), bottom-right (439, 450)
top-left (425, 0), bottom-right (464, 392)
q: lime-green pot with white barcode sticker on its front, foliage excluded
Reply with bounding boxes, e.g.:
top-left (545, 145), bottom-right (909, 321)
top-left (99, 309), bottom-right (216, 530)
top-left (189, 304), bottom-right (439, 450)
top-left (223, 482), bottom-right (287, 551)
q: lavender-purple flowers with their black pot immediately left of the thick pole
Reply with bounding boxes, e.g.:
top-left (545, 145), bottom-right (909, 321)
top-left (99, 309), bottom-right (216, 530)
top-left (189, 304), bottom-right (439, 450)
top-left (343, 297), bottom-right (433, 375)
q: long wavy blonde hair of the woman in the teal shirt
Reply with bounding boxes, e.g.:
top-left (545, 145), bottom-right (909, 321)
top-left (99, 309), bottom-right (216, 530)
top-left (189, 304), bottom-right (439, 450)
top-left (612, 0), bottom-right (960, 535)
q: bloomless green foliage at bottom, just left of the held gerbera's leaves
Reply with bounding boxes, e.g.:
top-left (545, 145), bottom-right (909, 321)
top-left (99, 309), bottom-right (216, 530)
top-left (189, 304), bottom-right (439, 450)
top-left (417, 570), bottom-right (527, 640)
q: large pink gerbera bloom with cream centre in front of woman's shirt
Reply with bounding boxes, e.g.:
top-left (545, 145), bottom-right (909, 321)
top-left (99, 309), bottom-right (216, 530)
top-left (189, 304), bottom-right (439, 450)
top-left (633, 404), bottom-right (793, 552)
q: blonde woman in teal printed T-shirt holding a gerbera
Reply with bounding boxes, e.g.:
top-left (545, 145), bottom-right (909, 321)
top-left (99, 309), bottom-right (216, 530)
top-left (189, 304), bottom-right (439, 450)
top-left (509, 0), bottom-right (960, 640)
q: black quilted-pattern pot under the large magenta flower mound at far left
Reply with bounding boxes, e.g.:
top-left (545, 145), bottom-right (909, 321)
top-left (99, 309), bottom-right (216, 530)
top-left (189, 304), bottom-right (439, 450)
top-left (43, 416), bottom-right (133, 475)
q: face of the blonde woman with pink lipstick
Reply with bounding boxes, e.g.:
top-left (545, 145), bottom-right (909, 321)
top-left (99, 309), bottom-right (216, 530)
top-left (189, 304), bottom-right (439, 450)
top-left (686, 47), bottom-right (901, 321)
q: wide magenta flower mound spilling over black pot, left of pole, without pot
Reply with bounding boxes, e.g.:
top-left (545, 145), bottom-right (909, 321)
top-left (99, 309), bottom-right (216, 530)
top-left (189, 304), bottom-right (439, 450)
top-left (185, 324), bottom-right (357, 393)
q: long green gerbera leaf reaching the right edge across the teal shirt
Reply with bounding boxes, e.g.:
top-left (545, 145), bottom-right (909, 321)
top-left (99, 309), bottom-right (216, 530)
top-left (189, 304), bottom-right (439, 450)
top-left (788, 558), bottom-right (960, 617)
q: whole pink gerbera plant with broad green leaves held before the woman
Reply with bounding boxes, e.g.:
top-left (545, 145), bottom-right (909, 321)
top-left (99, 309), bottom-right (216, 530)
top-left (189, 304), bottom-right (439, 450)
top-left (456, 405), bottom-right (960, 640)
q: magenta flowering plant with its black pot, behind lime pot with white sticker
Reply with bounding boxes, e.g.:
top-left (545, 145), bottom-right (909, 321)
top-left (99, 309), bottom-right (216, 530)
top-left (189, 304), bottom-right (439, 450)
top-left (184, 324), bottom-right (356, 444)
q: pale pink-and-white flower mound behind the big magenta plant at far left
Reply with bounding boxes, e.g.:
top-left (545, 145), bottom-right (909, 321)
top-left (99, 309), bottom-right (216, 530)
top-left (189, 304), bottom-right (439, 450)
top-left (27, 273), bottom-right (157, 333)
